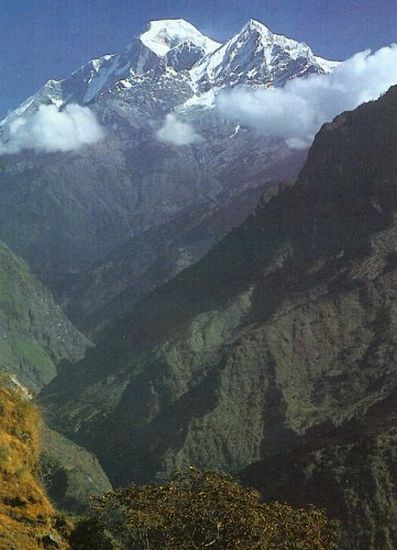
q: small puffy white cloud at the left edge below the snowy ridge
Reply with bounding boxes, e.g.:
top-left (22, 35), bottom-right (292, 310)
top-left (0, 104), bottom-right (104, 154)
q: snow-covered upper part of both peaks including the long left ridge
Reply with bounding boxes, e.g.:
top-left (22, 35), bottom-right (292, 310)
top-left (2, 19), bottom-right (337, 127)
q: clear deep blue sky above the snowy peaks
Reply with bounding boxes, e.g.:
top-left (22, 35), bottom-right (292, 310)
top-left (0, 0), bottom-right (397, 117)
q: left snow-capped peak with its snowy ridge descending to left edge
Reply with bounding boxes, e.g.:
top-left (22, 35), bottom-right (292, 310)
top-left (2, 19), bottom-right (215, 126)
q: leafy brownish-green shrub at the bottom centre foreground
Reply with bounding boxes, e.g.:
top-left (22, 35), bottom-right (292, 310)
top-left (71, 468), bottom-right (336, 550)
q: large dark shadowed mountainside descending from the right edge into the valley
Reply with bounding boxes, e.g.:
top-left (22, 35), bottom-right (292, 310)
top-left (42, 88), bottom-right (397, 548)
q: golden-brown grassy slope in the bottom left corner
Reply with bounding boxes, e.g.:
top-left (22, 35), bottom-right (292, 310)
top-left (0, 379), bottom-right (66, 550)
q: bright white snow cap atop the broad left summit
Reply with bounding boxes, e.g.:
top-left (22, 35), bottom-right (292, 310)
top-left (139, 19), bottom-right (221, 57)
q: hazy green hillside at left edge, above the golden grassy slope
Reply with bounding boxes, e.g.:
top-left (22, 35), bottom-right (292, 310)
top-left (0, 242), bottom-right (90, 390)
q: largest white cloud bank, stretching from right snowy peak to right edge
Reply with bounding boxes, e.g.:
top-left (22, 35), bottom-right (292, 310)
top-left (217, 44), bottom-right (397, 148)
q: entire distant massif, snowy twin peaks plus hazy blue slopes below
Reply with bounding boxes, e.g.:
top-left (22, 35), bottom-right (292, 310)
top-left (0, 20), bottom-right (336, 336)
